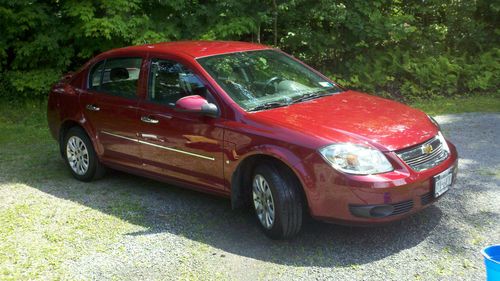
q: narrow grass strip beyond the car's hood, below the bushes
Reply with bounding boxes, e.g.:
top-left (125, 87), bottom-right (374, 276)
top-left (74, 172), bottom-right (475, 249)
top-left (410, 94), bottom-right (500, 116)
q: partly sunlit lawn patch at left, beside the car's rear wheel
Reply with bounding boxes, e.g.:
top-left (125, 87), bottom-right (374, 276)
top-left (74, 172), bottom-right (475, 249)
top-left (0, 100), bottom-right (148, 280)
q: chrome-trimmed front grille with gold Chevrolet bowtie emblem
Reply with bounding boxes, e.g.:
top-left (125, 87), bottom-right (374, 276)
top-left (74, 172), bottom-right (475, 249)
top-left (396, 135), bottom-right (449, 172)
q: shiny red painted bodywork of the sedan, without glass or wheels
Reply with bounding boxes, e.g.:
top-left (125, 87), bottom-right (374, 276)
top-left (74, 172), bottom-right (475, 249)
top-left (47, 41), bottom-right (457, 224)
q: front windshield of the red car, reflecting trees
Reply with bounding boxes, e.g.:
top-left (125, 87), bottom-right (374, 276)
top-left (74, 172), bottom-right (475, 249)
top-left (198, 50), bottom-right (340, 111)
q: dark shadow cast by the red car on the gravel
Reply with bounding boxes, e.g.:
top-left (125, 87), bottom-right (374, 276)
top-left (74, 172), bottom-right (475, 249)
top-left (4, 112), bottom-right (500, 267)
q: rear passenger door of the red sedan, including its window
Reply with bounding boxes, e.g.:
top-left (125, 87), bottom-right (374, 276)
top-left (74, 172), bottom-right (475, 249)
top-left (80, 57), bottom-right (144, 167)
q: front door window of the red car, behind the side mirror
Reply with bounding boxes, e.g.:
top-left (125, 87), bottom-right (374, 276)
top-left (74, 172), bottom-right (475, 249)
top-left (148, 59), bottom-right (207, 106)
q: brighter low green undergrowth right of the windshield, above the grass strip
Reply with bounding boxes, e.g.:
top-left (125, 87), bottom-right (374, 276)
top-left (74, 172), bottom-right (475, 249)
top-left (331, 48), bottom-right (500, 100)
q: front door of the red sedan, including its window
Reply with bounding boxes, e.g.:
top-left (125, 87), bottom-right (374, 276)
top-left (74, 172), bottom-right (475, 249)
top-left (138, 59), bottom-right (224, 190)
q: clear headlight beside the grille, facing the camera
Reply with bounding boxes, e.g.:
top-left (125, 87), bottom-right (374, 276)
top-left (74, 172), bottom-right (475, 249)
top-left (319, 143), bottom-right (394, 175)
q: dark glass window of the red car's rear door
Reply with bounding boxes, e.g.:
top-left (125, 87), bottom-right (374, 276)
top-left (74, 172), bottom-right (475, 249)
top-left (89, 58), bottom-right (142, 98)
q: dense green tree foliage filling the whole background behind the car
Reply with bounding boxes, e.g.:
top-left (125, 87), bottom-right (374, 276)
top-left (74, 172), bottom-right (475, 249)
top-left (0, 0), bottom-right (500, 100)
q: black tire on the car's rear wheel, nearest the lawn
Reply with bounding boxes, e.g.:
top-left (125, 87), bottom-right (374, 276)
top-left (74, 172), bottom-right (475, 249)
top-left (61, 127), bottom-right (106, 182)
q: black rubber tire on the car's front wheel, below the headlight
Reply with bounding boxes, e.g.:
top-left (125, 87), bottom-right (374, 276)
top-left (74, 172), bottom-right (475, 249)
top-left (250, 161), bottom-right (304, 239)
